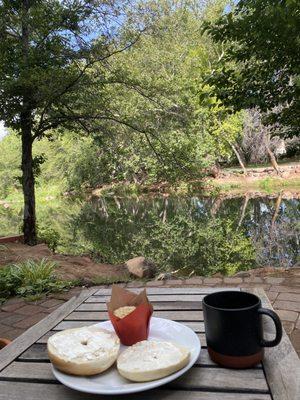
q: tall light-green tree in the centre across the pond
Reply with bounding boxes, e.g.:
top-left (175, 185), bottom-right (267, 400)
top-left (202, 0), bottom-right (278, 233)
top-left (85, 0), bottom-right (242, 183)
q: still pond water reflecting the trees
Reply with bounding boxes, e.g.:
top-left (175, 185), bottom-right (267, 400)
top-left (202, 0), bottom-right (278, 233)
top-left (2, 194), bottom-right (300, 276)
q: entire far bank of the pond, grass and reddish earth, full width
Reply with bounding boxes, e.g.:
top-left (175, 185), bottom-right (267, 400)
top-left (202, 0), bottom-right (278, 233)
top-left (0, 162), bottom-right (300, 203)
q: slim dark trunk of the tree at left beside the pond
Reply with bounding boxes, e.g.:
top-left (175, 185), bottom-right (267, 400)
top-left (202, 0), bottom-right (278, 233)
top-left (20, 0), bottom-right (37, 246)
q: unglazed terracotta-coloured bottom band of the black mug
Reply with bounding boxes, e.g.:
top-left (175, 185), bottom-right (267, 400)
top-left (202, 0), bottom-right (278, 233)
top-left (207, 347), bottom-right (264, 369)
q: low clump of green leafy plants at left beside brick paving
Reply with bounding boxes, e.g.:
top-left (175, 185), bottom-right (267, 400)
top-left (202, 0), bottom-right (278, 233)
top-left (0, 259), bottom-right (73, 299)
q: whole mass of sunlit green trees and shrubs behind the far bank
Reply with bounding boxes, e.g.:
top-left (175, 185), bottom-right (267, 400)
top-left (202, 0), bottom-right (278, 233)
top-left (0, 0), bottom-right (242, 198)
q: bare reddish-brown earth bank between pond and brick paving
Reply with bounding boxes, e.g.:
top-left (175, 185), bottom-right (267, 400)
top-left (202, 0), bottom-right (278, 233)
top-left (0, 242), bottom-right (300, 286)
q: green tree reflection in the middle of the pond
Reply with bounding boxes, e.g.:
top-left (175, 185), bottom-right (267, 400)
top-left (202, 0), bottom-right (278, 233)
top-left (69, 198), bottom-right (255, 275)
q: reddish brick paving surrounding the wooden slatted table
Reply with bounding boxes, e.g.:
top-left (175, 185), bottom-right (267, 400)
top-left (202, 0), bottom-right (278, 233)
top-left (0, 273), bottom-right (300, 357)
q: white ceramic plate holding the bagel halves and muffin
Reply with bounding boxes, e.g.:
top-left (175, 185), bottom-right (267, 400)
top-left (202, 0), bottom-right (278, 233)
top-left (52, 317), bottom-right (201, 394)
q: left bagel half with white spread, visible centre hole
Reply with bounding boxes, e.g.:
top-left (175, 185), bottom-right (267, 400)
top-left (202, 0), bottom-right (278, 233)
top-left (47, 326), bottom-right (120, 376)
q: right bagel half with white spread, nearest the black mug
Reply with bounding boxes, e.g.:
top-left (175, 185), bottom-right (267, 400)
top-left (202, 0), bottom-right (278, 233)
top-left (117, 340), bottom-right (190, 382)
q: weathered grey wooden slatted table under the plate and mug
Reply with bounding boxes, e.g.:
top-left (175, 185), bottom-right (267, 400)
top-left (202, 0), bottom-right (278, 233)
top-left (0, 288), bottom-right (300, 400)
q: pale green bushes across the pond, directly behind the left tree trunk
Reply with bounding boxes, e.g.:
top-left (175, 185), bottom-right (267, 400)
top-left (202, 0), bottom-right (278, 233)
top-left (0, 131), bottom-right (95, 195)
